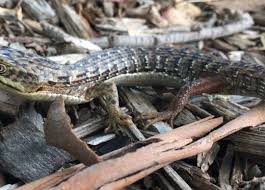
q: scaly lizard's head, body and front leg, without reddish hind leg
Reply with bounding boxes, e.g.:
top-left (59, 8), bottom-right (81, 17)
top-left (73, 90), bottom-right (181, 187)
top-left (0, 46), bottom-right (260, 128)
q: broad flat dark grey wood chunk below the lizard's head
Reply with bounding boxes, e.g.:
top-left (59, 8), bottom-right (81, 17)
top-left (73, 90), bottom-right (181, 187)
top-left (0, 107), bottom-right (71, 182)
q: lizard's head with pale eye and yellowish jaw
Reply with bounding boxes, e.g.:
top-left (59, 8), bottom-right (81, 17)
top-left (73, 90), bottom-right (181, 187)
top-left (0, 46), bottom-right (43, 94)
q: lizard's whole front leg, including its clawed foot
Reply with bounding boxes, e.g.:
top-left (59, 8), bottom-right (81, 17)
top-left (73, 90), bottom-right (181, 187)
top-left (85, 83), bottom-right (133, 131)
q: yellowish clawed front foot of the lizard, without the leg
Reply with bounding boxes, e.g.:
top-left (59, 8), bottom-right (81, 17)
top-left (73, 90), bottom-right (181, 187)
top-left (105, 110), bottom-right (133, 133)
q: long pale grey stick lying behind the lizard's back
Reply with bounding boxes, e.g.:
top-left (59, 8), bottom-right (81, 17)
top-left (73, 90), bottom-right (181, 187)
top-left (91, 13), bottom-right (253, 47)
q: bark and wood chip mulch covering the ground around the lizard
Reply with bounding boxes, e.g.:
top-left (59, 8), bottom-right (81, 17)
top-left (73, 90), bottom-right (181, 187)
top-left (0, 0), bottom-right (265, 190)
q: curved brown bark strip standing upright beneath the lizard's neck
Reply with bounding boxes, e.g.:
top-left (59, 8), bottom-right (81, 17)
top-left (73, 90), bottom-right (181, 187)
top-left (44, 98), bottom-right (100, 166)
